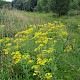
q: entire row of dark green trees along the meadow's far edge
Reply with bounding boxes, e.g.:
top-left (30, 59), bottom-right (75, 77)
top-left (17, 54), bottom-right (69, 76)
top-left (0, 0), bottom-right (80, 16)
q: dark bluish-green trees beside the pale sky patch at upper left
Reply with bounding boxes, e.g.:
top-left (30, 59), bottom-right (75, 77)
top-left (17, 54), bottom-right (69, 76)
top-left (12, 0), bottom-right (37, 11)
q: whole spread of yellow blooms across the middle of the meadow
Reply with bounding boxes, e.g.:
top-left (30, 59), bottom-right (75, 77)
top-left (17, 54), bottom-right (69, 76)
top-left (0, 21), bottom-right (72, 79)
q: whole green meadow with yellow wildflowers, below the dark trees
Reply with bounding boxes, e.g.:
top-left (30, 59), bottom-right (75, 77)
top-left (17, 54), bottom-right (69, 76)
top-left (0, 9), bottom-right (80, 80)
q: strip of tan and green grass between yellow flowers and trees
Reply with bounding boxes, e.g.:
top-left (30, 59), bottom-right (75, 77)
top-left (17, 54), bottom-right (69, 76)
top-left (0, 10), bottom-right (80, 36)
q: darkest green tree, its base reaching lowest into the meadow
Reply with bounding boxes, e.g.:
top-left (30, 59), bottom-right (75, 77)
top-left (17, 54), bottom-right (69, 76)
top-left (55, 0), bottom-right (70, 16)
